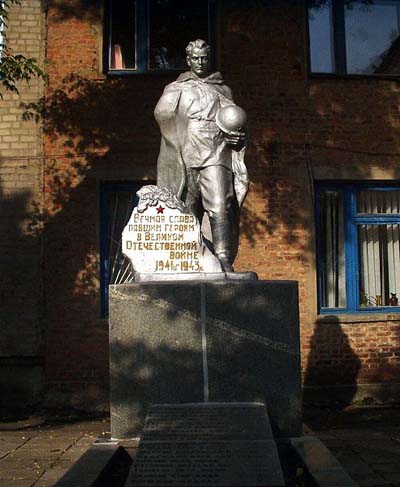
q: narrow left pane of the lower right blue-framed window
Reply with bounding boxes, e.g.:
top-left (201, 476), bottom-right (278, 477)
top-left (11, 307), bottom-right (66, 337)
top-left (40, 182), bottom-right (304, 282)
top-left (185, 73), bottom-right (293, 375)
top-left (319, 191), bottom-right (346, 308)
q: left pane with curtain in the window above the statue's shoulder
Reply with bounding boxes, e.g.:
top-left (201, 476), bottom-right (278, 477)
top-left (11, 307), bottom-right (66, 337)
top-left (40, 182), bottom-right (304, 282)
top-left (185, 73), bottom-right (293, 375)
top-left (110, 0), bottom-right (136, 69)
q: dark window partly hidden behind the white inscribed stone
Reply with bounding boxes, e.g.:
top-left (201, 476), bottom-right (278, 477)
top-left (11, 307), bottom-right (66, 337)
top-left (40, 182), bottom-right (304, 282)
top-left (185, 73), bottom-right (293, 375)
top-left (100, 182), bottom-right (150, 317)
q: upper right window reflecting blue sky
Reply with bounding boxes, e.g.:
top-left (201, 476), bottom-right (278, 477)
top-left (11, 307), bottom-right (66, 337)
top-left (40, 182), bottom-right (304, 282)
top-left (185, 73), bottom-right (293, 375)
top-left (308, 0), bottom-right (400, 75)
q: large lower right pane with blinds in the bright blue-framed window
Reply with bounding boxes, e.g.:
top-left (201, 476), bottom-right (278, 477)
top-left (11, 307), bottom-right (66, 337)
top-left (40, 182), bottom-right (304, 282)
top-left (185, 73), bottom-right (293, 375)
top-left (358, 224), bottom-right (400, 307)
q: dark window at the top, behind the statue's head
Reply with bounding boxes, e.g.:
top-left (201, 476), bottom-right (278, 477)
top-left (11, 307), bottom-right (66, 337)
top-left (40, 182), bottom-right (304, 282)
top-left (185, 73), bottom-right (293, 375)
top-left (106, 0), bottom-right (213, 74)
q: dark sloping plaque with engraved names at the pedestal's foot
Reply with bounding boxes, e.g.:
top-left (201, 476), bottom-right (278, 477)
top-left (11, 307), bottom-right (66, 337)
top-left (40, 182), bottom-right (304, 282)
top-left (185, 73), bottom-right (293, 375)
top-left (125, 403), bottom-right (285, 487)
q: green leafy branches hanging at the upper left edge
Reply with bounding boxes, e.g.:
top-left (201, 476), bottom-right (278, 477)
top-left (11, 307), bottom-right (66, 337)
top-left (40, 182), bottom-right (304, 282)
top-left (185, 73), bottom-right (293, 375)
top-left (0, 0), bottom-right (45, 97)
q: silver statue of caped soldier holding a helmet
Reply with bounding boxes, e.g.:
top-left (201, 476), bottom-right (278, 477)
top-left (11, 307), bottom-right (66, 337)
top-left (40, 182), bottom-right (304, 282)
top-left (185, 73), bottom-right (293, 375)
top-left (154, 39), bottom-right (248, 271)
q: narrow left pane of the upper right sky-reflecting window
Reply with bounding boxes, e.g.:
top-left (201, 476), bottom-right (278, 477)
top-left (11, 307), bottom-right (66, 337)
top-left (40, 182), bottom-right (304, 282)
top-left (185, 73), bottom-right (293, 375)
top-left (308, 1), bottom-right (334, 73)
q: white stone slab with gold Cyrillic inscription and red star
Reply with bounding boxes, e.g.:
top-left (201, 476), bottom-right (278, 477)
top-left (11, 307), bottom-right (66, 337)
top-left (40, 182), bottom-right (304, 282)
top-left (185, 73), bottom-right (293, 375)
top-left (122, 186), bottom-right (221, 276)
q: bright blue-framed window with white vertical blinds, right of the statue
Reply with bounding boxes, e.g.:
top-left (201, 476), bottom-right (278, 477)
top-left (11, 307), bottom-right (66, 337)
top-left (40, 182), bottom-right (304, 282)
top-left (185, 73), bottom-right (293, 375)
top-left (316, 184), bottom-right (400, 313)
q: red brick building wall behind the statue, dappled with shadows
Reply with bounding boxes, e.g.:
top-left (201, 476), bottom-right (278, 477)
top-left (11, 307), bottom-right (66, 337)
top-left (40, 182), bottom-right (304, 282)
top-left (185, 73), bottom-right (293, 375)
top-left (45, 1), bottom-right (400, 404)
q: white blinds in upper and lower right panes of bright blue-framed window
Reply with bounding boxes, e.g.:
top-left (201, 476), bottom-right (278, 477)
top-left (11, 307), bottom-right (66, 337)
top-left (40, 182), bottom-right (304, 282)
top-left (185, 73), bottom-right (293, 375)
top-left (357, 191), bottom-right (400, 307)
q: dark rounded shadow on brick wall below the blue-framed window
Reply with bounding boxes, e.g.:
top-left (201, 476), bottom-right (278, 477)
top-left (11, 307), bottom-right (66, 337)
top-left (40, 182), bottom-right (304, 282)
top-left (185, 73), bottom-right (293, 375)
top-left (303, 316), bottom-right (361, 408)
